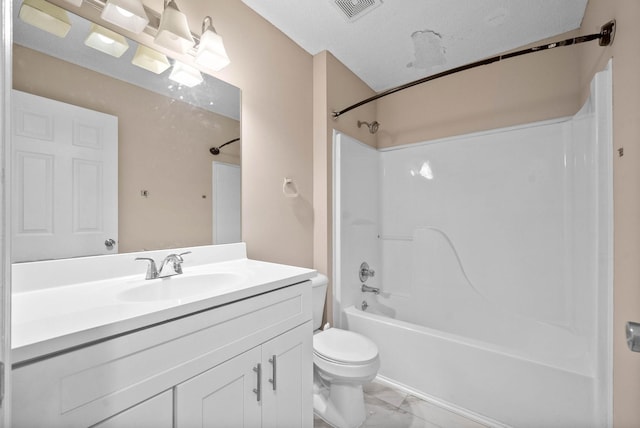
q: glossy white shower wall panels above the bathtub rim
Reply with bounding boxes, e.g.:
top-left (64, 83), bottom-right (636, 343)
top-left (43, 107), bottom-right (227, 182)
top-left (335, 113), bottom-right (598, 352)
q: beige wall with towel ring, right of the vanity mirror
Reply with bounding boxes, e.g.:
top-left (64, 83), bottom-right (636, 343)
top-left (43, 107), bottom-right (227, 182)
top-left (180, 0), bottom-right (314, 267)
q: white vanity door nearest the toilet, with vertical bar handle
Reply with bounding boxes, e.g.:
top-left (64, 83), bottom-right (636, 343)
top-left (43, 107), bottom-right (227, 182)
top-left (262, 321), bottom-right (313, 428)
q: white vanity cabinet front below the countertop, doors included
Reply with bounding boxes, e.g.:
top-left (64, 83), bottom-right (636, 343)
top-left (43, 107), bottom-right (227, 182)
top-left (12, 281), bottom-right (313, 428)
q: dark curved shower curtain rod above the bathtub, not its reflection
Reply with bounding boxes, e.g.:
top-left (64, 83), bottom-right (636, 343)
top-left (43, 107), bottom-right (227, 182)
top-left (332, 19), bottom-right (616, 120)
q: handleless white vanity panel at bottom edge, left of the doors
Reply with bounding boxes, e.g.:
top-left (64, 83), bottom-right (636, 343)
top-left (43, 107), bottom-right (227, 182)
top-left (93, 390), bottom-right (173, 428)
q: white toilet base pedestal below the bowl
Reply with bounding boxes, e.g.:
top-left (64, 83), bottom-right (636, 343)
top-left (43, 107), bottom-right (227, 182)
top-left (313, 374), bottom-right (367, 428)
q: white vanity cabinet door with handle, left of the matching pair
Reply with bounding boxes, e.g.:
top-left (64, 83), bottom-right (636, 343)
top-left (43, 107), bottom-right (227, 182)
top-left (175, 347), bottom-right (261, 428)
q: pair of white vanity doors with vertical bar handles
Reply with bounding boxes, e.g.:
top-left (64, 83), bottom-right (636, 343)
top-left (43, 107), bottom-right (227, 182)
top-left (175, 323), bottom-right (313, 428)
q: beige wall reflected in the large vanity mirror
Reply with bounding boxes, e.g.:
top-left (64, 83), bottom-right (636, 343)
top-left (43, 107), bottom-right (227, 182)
top-left (13, 45), bottom-right (240, 252)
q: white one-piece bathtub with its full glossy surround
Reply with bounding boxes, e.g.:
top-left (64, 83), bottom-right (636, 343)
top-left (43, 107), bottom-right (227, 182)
top-left (333, 62), bottom-right (613, 427)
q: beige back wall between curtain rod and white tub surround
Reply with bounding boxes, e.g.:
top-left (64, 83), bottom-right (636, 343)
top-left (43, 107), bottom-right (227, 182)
top-left (378, 33), bottom-right (580, 147)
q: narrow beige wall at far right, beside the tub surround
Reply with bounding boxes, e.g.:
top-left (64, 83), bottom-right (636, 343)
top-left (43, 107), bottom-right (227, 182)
top-left (580, 0), bottom-right (640, 428)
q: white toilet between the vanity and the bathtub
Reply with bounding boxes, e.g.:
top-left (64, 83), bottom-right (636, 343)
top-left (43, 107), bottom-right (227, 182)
top-left (311, 274), bottom-right (380, 428)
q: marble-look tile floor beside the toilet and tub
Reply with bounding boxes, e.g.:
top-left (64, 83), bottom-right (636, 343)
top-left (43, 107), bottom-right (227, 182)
top-left (313, 382), bottom-right (486, 428)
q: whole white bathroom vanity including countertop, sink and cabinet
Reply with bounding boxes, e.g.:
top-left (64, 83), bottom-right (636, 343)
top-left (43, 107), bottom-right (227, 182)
top-left (12, 244), bottom-right (315, 428)
